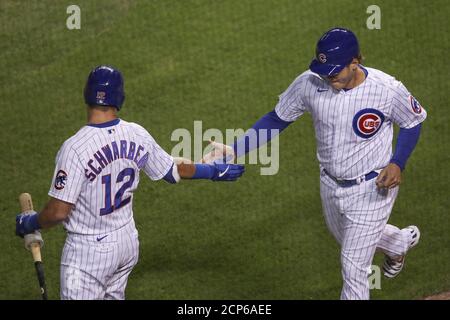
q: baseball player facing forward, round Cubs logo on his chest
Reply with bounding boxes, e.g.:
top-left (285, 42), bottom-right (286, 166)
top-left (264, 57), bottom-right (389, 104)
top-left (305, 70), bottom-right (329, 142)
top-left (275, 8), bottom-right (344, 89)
top-left (207, 28), bottom-right (427, 299)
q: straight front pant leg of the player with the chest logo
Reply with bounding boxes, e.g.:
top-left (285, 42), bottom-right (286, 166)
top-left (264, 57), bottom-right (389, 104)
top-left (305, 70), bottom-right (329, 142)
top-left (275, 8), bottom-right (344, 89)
top-left (341, 180), bottom-right (398, 299)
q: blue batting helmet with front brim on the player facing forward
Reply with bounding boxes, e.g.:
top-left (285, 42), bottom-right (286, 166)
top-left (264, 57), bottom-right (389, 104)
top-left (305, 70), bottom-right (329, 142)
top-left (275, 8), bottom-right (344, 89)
top-left (309, 28), bottom-right (359, 76)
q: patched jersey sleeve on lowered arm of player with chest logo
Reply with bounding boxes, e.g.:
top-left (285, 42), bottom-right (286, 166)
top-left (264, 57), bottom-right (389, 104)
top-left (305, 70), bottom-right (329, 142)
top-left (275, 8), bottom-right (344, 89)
top-left (391, 81), bottom-right (427, 129)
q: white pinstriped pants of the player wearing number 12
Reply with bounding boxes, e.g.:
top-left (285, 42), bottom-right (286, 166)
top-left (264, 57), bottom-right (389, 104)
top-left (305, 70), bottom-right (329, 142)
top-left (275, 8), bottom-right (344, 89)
top-left (60, 220), bottom-right (139, 300)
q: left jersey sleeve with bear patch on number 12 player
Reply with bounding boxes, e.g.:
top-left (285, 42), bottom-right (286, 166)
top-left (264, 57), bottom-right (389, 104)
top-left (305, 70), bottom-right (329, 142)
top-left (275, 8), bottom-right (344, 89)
top-left (48, 143), bottom-right (86, 204)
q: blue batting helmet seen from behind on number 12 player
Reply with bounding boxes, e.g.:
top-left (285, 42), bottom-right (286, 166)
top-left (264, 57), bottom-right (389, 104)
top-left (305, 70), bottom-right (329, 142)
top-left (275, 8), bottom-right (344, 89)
top-left (84, 66), bottom-right (125, 110)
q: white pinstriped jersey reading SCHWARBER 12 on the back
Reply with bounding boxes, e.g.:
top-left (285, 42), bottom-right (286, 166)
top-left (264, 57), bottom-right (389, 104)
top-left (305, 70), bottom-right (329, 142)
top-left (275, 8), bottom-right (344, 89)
top-left (48, 119), bottom-right (173, 235)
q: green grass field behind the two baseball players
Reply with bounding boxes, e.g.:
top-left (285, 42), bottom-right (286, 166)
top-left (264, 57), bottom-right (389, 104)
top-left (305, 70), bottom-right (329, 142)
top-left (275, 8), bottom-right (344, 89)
top-left (0, 0), bottom-right (450, 299)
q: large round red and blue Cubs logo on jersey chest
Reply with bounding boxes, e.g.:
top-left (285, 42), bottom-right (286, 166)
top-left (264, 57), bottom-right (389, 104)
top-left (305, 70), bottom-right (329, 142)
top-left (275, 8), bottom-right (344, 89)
top-left (353, 108), bottom-right (384, 139)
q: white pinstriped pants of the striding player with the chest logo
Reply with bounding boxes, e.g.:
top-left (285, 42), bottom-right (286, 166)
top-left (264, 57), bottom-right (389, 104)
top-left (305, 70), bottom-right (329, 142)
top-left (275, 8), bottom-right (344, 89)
top-left (320, 170), bottom-right (410, 300)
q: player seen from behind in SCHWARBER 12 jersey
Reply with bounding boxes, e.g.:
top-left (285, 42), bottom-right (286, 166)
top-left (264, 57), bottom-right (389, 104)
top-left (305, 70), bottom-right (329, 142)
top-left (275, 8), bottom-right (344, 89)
top-left (16, 66), bottom-right (244, 299)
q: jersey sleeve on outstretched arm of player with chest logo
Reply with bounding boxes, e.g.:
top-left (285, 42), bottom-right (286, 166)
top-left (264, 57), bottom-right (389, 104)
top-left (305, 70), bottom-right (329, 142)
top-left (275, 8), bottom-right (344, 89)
top-left (275, 76), bottom-right (306, 122)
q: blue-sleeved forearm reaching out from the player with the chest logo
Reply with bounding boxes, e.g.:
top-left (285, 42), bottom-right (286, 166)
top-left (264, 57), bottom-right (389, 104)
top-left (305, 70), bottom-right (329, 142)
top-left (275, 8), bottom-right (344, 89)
top-left (232, 110), bottom-right (292, 158)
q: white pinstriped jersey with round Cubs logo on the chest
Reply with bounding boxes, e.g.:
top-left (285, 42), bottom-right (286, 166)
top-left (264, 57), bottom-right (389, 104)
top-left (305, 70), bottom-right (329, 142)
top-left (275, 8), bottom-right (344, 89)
top-left (275, 66), bottom-right (427, 179)
